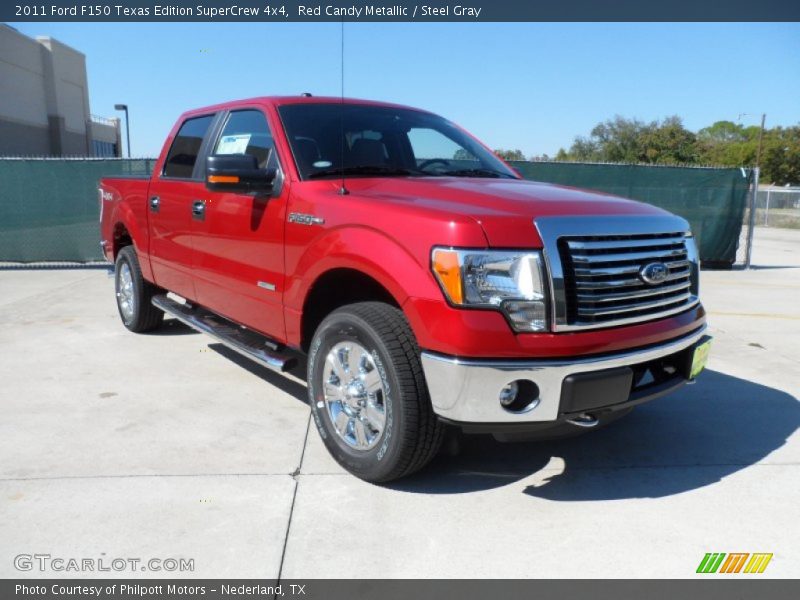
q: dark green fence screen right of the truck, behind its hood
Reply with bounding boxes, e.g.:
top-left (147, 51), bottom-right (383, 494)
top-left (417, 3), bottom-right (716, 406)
top-left (511, 161), bottom-right (752, 267)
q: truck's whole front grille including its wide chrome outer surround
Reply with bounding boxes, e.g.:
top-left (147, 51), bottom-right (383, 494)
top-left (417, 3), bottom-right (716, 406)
top-left (535, 215), bottom-right (698, 331)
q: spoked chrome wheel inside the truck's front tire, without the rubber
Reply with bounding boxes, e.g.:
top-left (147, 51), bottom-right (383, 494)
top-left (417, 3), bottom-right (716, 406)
top-left (322, 342), bottom-right (386, 451)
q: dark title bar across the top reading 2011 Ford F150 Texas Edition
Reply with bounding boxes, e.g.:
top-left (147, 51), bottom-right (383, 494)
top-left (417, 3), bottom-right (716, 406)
top-left (0, 0), bottom-right (800, 23)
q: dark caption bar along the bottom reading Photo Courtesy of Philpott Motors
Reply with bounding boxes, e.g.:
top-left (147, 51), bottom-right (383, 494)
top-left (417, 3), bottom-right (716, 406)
top-left (0, 574), bottom-right (800, 600)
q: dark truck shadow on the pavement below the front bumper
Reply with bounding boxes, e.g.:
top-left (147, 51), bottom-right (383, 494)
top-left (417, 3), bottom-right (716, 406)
top-left (390, 371), bottom-right (800, 502)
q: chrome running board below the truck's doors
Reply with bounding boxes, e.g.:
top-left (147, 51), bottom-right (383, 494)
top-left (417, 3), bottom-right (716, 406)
top-left (152, 294), bottom-right (297, 373)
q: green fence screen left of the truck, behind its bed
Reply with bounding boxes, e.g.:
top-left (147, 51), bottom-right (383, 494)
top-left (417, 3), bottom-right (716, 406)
top-left (0, 159), bottom-right (155, 263)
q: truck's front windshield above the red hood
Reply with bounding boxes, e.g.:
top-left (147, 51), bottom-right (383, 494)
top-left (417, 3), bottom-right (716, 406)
top-left (278, 104), bottom-right (517, 179)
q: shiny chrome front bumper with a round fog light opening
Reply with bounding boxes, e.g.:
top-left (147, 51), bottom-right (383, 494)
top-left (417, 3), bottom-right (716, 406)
top-left (422, 325), bottom-right (706, 424)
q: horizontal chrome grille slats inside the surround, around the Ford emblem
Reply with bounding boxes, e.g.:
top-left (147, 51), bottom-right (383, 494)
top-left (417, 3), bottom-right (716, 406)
top-left (559, 232), bottom-right (692, 325)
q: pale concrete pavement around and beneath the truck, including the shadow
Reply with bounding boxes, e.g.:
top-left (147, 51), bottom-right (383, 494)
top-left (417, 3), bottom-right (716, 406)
top-left (0, 229), bottom-right (800, 579)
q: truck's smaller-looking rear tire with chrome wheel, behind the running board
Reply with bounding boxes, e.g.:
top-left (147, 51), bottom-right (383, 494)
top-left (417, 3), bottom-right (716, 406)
top-left (114, 246), bottom-right (164, 333)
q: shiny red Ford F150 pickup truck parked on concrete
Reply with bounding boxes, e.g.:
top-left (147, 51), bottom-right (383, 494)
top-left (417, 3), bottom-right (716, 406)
top-left (100, 94), bottom-right (710, 482)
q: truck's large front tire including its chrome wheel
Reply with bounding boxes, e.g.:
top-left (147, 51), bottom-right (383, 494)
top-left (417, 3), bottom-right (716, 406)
top-left (308, 302), bottom-right (443, 483)
